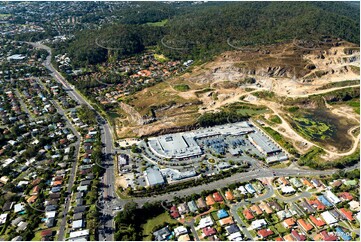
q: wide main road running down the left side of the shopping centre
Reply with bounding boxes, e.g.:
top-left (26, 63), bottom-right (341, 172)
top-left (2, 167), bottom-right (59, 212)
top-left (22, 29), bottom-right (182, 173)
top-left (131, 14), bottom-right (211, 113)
top-left (27, 42), bottom-right (118, 241)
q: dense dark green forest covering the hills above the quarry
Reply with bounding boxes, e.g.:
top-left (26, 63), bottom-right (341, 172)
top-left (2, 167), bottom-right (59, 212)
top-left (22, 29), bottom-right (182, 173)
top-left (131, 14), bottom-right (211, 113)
top-left (57, 2), bottom-right (360, 65)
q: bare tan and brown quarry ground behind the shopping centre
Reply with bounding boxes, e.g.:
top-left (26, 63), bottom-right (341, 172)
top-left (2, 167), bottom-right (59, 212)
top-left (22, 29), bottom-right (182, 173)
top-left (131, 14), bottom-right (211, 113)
top-left (117, 39), bottom-right (360, 161)
